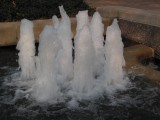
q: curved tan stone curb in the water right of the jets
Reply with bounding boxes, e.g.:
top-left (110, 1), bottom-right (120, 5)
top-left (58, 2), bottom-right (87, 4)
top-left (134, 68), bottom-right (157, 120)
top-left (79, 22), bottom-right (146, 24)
top-left (124, 45), bottom-right (160, 83)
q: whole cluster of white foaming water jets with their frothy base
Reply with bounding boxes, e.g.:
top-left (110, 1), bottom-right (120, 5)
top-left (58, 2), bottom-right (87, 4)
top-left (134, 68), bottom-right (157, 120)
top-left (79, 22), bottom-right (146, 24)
top-left (17, 6), bottom-right (128, 103)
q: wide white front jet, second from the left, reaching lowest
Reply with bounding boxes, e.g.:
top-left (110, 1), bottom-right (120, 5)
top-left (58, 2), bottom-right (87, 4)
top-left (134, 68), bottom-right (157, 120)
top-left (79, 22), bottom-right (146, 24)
top-left (33, 25), bottom-right (61, 102)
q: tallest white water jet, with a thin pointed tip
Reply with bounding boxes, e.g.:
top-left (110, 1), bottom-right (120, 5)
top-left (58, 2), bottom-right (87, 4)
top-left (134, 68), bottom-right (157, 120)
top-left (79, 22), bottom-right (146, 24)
top-left (57, 6), bottom-right (73, 82)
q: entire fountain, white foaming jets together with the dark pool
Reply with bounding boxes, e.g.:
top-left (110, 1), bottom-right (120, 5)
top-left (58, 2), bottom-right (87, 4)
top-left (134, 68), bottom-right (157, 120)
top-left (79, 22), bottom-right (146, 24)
top-left (0, 6), bottom-right (160, 120)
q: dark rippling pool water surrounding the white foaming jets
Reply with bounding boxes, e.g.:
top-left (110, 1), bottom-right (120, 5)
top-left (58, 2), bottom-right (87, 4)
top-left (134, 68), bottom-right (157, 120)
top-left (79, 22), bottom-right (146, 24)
top-left (0, 45), bottom-right (160, 120)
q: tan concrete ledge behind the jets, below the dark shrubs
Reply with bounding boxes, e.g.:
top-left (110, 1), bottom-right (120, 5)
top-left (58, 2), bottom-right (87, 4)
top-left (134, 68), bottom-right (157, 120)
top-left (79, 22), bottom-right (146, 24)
top-left (0, 18), bottom-right (111, 46)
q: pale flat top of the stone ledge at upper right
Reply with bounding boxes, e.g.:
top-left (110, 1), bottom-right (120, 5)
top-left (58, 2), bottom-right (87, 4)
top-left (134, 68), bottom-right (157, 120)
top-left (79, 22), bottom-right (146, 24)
top-left (97, 5), bottom-right (160, 27)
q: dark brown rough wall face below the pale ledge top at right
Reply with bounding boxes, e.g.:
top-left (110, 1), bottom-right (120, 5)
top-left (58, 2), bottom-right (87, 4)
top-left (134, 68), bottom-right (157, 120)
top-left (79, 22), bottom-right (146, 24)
top-left (119, 19), bottom-right (160, 47)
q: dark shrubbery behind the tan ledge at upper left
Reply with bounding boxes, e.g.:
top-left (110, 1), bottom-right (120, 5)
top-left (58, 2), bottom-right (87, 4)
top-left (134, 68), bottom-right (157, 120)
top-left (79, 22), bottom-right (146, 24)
top-left (0, 0), bottom-right (95, 22)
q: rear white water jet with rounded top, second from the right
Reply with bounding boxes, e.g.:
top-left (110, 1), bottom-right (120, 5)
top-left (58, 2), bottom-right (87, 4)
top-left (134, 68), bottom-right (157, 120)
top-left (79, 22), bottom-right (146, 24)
top-left (90, 12), bottom-right (105, 76)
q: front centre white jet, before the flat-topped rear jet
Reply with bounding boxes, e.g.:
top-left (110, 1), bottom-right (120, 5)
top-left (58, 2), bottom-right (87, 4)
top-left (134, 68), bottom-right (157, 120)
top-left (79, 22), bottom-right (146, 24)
top-left (72, 26), bottom-right (94, 97)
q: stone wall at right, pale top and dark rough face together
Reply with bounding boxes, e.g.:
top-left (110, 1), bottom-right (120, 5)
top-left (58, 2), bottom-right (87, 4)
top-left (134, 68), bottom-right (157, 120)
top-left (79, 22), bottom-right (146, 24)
top-left (97, 5), bottom-right (160, 59)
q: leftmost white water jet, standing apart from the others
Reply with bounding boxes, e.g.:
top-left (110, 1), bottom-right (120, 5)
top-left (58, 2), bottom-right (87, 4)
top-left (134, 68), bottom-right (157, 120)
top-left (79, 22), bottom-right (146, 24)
top-left (16, 19), bottom-right (36, 79)
